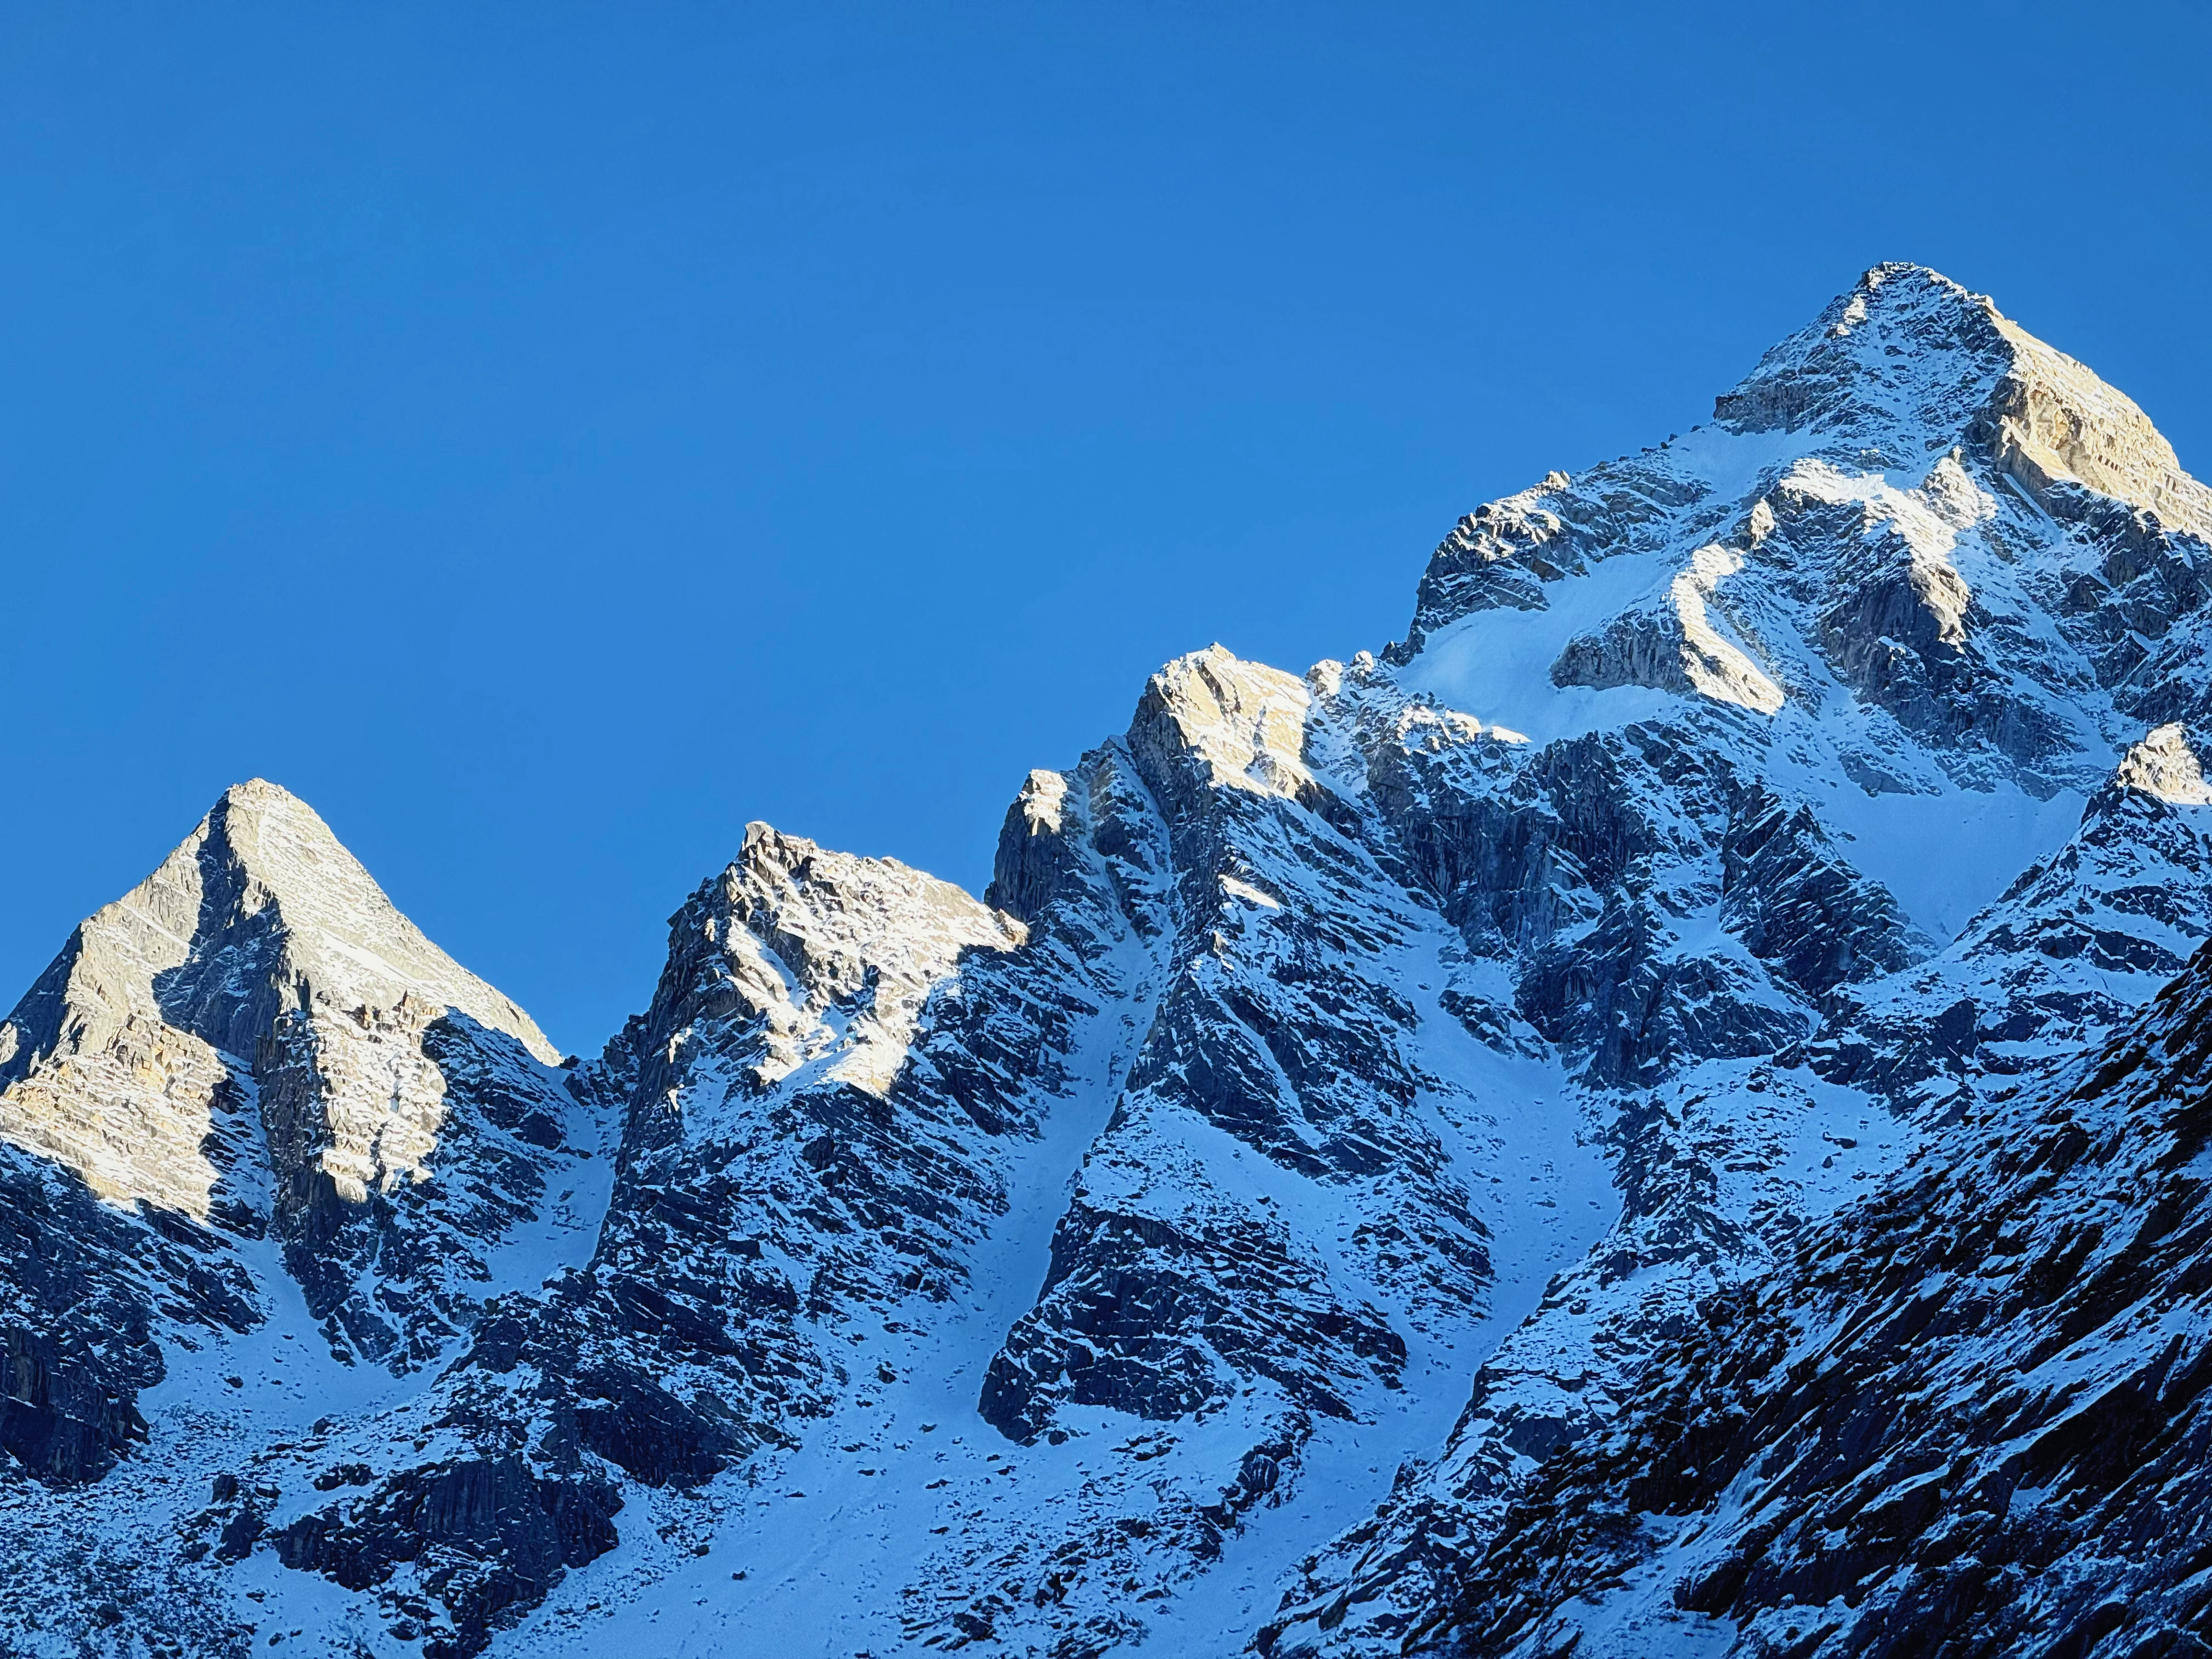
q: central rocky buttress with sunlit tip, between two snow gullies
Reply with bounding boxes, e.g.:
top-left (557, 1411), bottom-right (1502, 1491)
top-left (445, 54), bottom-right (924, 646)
top-left (909, 648), bottom-right (1604, 1652)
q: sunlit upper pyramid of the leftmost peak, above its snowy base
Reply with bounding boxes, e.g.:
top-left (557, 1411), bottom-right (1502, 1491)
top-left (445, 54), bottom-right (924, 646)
top-left (0, 778), bottom-right (595, 1398)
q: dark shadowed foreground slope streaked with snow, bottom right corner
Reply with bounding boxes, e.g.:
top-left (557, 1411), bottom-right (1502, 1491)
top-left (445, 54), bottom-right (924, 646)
top-left (1418, 949), bottom-right (2212, 1657)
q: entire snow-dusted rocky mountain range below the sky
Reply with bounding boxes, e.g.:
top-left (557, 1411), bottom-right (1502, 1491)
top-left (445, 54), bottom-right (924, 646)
top-left (0, 266), bottom-right (2212, 1659)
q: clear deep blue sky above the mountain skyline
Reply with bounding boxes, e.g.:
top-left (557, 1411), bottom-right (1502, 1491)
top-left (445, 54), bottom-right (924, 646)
top-left (0, 4), bottom-right (2212, 1048)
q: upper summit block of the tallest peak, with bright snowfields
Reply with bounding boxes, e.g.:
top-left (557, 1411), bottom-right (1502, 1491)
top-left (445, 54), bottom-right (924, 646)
top-left (1385, 266), bottom-right (2212, 832)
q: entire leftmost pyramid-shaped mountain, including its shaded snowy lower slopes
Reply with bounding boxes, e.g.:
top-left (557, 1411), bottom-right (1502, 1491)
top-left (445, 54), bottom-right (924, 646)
top-left (0, 781), bottom-right (606, 1652)
